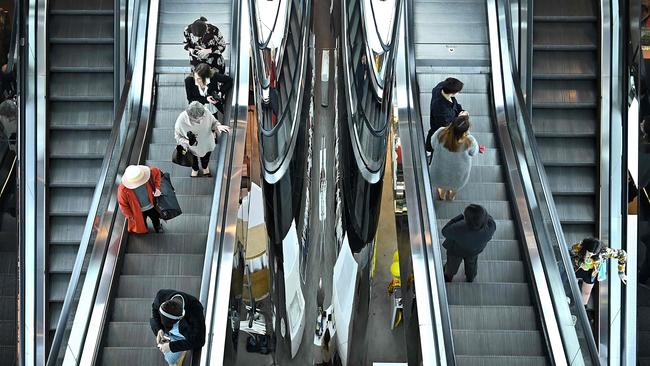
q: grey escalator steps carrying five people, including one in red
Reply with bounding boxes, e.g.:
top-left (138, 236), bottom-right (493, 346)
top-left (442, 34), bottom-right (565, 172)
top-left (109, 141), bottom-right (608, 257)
top-left (99, 0), bottom-right (231, 365)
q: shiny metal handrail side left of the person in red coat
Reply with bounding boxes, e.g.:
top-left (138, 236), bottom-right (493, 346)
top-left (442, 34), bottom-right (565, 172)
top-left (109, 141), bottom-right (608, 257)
top-left (47, 0), bottom-right (157, 365)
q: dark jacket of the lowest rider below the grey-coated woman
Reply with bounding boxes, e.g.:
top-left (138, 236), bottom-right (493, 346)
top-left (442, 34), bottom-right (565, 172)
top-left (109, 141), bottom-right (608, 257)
top-left (442, 215), bottom-right (497, 258)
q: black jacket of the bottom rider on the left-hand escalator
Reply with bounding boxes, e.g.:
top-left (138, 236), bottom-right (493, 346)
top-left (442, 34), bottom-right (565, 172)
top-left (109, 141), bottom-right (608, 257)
top-left (149, 290), bottom-right (205, 352)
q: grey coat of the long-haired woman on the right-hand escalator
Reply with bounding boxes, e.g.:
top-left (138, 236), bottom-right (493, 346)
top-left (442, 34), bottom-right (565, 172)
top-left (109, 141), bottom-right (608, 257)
top-left (430, 128), bottom-right (478, 191)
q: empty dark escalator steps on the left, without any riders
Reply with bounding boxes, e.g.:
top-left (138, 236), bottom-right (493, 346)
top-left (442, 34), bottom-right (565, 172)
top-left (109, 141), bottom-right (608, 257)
top-left (46, 0), bottom-right (119, 348)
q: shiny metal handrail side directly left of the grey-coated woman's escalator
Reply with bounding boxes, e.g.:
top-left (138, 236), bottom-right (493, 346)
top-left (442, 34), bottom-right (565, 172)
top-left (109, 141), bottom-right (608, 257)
top-left (396, 1), bottom-right (456, 366)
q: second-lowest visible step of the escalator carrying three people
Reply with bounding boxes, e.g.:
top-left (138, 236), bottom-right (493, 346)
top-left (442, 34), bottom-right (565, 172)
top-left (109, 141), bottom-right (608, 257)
top-left (453, 330), bottom-right (546, 356)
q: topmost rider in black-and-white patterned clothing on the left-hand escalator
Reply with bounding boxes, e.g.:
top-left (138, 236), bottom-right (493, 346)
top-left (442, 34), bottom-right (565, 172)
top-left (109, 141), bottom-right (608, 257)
top-left (183, 17), bottom-right (226, 74)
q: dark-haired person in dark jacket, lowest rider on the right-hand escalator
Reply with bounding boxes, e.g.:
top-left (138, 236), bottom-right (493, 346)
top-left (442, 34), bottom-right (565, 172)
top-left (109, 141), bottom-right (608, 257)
top-left (442, 204), bottom-right (496, 282)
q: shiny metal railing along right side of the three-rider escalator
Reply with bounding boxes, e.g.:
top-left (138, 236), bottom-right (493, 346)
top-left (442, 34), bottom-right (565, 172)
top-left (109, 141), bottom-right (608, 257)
top-left (488, 0), bottom-right (599, 365)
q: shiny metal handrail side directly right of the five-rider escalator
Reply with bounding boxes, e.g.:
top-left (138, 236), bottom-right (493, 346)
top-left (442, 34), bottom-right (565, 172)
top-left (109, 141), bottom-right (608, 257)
top-left (198, 0), bottom-right (251, 366)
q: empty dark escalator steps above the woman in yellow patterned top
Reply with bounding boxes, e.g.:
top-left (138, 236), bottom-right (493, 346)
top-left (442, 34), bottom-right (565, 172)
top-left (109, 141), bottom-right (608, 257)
top-left (532, 0), bottom-right (600, 245)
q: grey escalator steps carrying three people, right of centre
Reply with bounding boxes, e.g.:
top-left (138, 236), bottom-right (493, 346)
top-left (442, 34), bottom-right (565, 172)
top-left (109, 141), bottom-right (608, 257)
top-left (407, 1), bottom-right (551, 365)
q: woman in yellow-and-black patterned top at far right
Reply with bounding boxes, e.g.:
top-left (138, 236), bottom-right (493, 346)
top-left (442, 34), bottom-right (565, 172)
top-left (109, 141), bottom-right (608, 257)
top-left (571, 238), bottom-right (627, 306)
